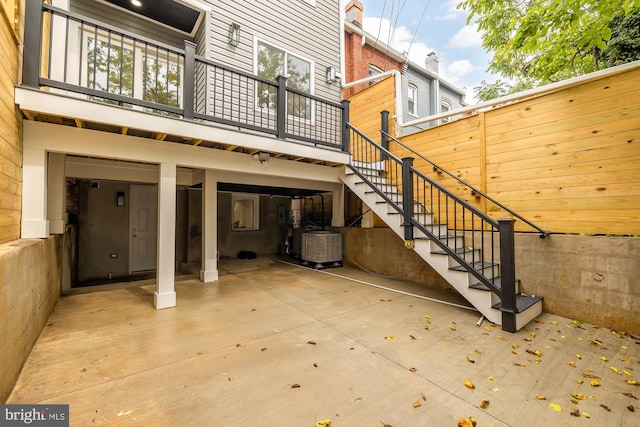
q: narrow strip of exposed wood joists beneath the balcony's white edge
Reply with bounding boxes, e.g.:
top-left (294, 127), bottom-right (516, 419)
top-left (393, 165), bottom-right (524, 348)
top-left (21, 103), bottom-right (344, 167)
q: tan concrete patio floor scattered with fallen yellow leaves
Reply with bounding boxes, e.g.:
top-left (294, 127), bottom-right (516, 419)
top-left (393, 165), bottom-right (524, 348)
top-left (7, 259), bottom-right (640, 427)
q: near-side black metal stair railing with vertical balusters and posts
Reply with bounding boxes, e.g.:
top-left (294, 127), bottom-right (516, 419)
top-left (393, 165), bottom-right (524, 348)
top-left (348, 125), bottom-right (517, 332)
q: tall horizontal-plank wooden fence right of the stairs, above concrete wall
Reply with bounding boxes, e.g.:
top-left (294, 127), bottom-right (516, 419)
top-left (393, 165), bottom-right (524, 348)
top-left (392, 67), bottom-right (640, 235)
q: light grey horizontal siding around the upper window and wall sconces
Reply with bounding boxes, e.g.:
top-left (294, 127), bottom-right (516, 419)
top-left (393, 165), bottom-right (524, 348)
top-left (207, 0), bottom-right (342, 102)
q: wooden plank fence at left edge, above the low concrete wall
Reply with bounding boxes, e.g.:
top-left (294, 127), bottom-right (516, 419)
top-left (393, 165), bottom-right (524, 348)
top-left (0, 0), bottom-right (24, 243)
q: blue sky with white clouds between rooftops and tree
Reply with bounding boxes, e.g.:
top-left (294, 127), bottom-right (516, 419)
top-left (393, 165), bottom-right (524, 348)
top-left (360, 0), bottom-right (499, 104)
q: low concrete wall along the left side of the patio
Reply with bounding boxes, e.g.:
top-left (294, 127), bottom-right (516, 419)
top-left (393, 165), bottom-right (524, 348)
top-left (0, 236), bottom-right (62, 403)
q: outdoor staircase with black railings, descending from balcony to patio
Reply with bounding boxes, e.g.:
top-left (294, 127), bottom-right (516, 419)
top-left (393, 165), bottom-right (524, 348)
top-left (343, 124), bottom-right (548, 332)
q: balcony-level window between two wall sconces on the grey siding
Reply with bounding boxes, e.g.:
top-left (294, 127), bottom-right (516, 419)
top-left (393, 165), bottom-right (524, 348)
top-left (256, 41), bottom-right (313, 120)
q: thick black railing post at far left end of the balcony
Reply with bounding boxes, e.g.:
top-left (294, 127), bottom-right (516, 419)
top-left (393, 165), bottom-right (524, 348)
top-left (22, 0), bottom-right (43, 88)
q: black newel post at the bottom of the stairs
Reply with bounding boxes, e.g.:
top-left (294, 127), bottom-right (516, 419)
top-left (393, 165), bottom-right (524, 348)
top-left (498, 218), bottom-right (517, 332)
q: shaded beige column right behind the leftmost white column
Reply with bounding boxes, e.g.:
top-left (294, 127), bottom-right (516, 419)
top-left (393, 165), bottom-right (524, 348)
top-left (47, 153), bottom-right (67, 234)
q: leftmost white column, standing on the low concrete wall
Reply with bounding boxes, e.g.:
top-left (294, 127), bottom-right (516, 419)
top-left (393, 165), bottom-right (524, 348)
top-left (21, 147), bottom-right (49, 239)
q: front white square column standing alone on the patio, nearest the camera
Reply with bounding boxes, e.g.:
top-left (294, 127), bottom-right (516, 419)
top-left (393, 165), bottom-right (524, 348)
top-left (154, 163), bottom-right (176, 310)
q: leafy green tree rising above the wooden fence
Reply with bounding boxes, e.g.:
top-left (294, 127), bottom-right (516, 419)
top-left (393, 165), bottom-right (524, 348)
top-left (458, 0), bottom-right (640, 100)
